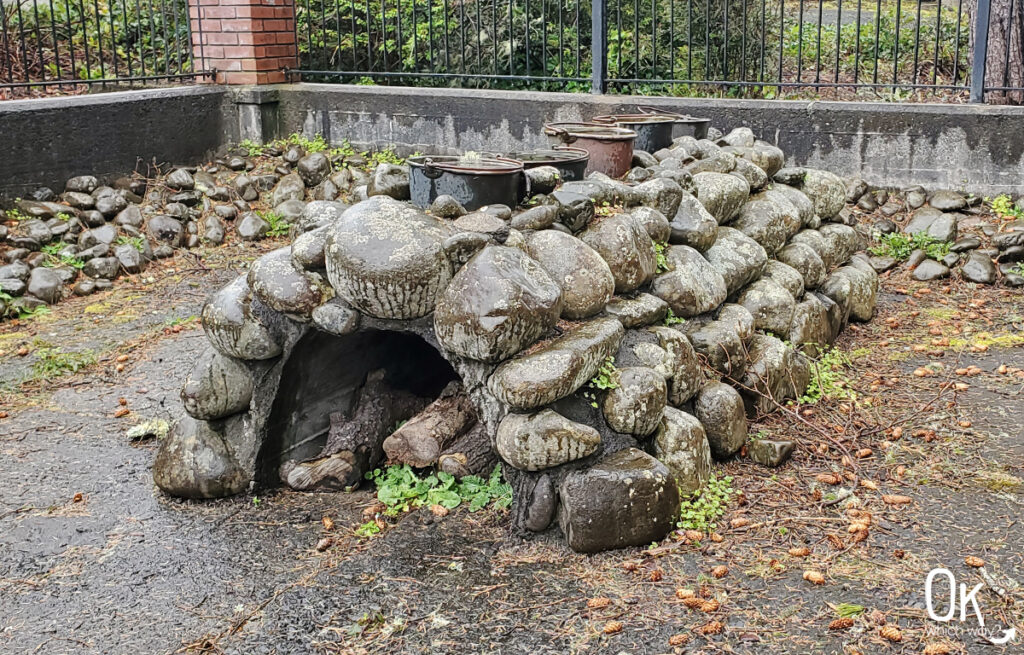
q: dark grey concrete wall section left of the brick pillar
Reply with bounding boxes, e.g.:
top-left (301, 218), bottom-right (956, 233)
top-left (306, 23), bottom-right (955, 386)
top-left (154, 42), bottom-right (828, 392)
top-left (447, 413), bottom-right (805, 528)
top-left (0, 85), bottom-right (226, 195)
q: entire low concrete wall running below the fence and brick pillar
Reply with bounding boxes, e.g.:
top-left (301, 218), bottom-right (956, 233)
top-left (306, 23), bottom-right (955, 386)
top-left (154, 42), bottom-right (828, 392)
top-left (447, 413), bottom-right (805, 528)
top-left (0, 84), bottom-right (1024, 197)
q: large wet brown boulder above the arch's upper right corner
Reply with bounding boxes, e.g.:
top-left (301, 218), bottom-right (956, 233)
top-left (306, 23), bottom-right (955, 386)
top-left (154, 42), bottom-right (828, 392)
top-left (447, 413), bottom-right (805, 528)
top-left (432, 245), bottom-right (562, 362)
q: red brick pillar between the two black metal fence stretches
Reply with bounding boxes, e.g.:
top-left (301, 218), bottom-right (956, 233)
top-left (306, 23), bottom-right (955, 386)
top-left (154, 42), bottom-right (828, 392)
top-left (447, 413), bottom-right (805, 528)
top-left (188, 0), bottom-right (299, 84)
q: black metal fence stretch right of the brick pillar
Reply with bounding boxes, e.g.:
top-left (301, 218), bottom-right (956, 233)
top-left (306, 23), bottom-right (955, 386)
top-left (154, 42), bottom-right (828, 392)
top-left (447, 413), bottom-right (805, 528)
top-left (297, 0), bottom-right (1024, 102)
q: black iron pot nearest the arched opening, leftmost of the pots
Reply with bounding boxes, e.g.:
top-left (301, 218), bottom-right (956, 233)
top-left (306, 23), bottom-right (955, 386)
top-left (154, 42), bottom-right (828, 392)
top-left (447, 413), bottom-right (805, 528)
top-left (408, 155), bottom-right (522, 211)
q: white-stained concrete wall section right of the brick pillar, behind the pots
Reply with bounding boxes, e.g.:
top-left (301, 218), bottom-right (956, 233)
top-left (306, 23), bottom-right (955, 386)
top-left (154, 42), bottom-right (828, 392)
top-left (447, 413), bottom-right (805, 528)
top-left (276, 84), bottom-right (1024, 194)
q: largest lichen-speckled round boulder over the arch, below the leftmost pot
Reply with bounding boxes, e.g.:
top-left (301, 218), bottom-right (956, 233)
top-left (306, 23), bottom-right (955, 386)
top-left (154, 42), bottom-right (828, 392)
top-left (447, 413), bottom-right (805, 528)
top-left (325, 195), bottom-right (452, 318)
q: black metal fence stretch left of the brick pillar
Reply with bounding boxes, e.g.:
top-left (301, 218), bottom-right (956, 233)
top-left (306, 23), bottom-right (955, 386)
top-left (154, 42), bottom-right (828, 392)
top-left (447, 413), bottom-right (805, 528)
top-left (0, 0), bottom-right (199, 99)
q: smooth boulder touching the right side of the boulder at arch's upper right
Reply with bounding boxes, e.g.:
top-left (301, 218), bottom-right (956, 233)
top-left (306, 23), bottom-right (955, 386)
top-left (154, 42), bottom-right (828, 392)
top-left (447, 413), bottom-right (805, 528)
top-left (526, 229), bottom-right (615, 319)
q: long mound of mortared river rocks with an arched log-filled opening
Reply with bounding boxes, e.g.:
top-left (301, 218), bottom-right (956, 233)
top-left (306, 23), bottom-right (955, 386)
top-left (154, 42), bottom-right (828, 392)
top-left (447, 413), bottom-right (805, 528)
top-left (154, 128), bottom-right (878, 552)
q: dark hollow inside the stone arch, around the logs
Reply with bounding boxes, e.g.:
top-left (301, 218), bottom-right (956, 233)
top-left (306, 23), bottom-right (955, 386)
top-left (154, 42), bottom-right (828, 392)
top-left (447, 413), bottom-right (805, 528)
top-left (257, 330), bottom-right (459, 489)
